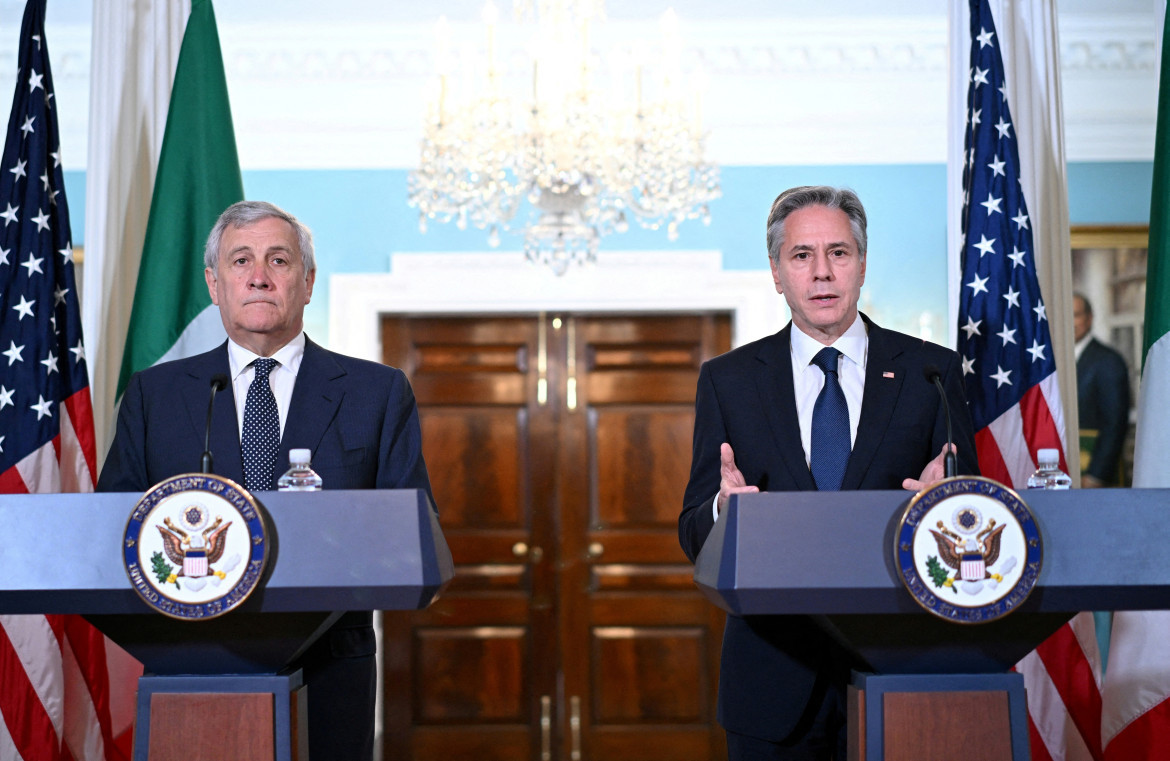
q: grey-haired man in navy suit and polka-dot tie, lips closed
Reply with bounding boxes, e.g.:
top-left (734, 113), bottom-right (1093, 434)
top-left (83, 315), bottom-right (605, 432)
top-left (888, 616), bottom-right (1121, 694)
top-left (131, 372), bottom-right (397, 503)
top-left (97, 196), bottom-right (433, 761)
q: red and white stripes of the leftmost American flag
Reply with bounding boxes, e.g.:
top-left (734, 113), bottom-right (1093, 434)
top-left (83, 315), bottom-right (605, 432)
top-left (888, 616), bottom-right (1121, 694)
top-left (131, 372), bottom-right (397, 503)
top-left (0, 389), bottom-right (143, 761)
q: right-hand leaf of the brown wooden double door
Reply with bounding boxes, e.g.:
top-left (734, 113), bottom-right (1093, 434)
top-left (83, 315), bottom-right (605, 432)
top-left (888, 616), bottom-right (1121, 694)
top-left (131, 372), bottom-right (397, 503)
top-left (559, 315), bottom-right (730, 761)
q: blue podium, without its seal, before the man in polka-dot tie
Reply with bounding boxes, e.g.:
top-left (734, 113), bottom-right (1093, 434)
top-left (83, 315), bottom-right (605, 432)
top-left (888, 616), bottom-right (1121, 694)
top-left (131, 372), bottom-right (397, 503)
top-left (0, 489), bottom-right (454, 761)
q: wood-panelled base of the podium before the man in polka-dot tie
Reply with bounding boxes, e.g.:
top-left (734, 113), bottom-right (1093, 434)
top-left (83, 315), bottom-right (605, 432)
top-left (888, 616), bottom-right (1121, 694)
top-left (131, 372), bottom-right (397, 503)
top-left (133, 670), bottom-right (309, 761)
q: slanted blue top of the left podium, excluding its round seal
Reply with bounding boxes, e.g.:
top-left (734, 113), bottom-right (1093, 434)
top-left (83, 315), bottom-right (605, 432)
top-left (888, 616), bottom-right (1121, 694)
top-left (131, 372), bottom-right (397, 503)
top-left (0, 489), bottom-right (454, 613)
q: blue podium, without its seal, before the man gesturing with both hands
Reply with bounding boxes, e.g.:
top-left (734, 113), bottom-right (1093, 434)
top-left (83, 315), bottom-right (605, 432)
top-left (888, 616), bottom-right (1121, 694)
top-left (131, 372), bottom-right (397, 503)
top-left (695, 489), bottom-right (1170, 761)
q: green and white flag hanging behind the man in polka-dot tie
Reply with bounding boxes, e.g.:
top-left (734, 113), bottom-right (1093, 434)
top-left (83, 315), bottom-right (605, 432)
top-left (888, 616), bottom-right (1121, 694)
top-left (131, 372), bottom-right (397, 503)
top-left (117, 0), bottom-right (243, 398)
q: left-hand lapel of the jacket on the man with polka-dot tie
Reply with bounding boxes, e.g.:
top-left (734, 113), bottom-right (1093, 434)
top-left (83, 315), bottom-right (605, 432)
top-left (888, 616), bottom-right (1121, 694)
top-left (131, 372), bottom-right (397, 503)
top-left (176, 342), bottom-right (243, 484)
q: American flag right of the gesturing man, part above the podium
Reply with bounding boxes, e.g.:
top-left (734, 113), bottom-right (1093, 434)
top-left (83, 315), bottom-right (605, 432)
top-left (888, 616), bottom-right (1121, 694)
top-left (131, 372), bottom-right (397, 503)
top-left (958, 0), bottom-right (1068, 477)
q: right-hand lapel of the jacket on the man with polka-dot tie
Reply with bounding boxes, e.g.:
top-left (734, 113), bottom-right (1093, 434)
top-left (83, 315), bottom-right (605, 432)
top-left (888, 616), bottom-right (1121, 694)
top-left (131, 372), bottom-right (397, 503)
top-left (273, 337), bottom-right (345, 481)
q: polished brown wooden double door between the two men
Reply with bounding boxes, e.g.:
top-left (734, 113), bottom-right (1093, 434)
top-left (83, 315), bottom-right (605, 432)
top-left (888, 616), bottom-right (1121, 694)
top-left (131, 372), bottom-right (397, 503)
top-left (381, 314), bottom-right (730, 761)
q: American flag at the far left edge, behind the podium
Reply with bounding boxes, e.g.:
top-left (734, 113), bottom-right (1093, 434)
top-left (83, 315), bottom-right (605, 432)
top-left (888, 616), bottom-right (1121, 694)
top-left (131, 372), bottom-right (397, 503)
top-left (0, 0), bottom-right (139, 761)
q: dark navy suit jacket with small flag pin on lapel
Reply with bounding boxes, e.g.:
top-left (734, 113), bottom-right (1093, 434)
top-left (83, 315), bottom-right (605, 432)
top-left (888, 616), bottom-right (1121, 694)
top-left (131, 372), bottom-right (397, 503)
top-left (679, 315), bottom-right (978, 741)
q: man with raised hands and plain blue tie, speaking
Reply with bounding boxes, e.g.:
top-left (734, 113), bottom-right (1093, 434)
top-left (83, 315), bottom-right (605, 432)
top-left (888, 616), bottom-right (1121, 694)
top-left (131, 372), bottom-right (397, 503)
top-left (679, 187), bottom-right (978, 761)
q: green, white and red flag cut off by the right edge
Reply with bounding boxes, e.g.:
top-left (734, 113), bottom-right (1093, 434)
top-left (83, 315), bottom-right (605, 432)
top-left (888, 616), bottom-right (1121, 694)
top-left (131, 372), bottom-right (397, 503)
top-left (1101, 5), bottom-right (1170, 761)
